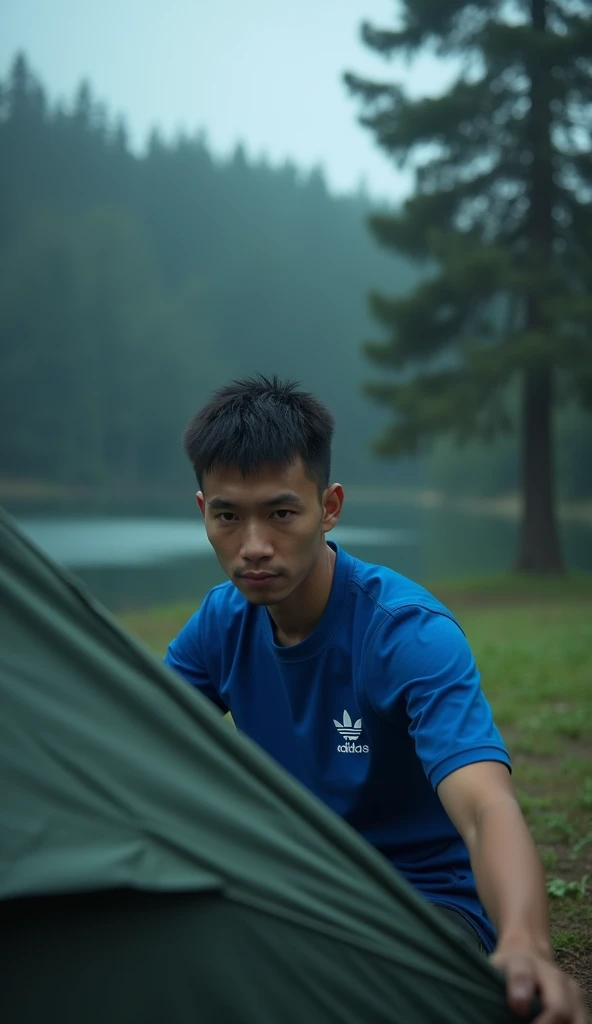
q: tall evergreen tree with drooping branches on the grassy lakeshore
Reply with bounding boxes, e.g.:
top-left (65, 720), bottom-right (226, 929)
top-left (346, 0), bottom-right (592, 571)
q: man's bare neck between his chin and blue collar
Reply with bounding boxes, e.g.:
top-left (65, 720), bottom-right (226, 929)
top-left (267, 544), bottom-right (336, 647)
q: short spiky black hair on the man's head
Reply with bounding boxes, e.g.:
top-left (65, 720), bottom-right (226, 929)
top-left (183, 374), bottom-right (334, 489)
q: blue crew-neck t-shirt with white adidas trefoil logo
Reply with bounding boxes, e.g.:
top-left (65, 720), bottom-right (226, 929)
top-left (166, 545), bottom-right (510, 950)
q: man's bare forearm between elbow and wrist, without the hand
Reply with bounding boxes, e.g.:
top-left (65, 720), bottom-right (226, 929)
top-left (468, 797), bottom-right (552, 956)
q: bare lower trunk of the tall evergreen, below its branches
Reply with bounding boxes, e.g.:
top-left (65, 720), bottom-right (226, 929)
top-left (514, 367), bottom-right (563, 572)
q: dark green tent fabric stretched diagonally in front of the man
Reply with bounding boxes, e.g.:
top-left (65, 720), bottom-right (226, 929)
top-left (0, 513), bottom-right (524, 1024)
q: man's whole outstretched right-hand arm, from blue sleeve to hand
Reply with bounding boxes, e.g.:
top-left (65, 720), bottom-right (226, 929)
top-left (368, 604), bottom-right (587, 1024)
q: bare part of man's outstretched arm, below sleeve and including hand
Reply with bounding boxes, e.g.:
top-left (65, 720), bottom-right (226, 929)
top-left (437, 761), bottom-right (588, 1024)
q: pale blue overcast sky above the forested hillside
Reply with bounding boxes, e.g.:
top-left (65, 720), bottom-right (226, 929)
top-left (0, 0), bottom-right (452, 202)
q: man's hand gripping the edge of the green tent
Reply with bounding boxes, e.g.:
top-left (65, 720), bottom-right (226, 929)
top-left (491, 946), bottom-right (589, 1024)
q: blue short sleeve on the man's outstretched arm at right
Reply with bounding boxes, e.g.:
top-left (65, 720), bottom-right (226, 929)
top-left (366, 606), bottom-right (510, 790)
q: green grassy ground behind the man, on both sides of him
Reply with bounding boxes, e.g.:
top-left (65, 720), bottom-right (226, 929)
top-left (119, 575), bottom-right (592, 998)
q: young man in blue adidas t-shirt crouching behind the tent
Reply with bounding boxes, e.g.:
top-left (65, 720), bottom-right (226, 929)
top-left (166, 377), bottom-right (587, 1024)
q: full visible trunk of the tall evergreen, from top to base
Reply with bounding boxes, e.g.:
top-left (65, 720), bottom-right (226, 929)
top-left (515, 0), bottom-right (563, 572)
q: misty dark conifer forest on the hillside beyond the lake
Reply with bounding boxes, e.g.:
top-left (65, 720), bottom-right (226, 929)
top-left (0, 55), bottom-right (419, 487)
